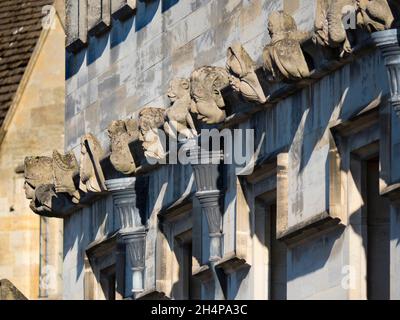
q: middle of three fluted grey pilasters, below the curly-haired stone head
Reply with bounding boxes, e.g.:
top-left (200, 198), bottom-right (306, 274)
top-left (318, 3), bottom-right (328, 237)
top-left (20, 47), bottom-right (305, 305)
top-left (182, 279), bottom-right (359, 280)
top-left (189, 145), bottom-right (223, 262)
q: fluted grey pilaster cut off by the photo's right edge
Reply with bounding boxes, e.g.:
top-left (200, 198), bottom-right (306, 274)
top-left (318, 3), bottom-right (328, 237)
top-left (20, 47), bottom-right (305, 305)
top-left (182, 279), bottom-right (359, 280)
top-left (371, 29), bottom-right (400, 117)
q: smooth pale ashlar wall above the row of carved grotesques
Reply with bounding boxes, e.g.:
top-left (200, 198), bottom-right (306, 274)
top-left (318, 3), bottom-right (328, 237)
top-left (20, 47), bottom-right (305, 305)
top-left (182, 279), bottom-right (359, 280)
top-left (65, 0), bottom-right (314, 153)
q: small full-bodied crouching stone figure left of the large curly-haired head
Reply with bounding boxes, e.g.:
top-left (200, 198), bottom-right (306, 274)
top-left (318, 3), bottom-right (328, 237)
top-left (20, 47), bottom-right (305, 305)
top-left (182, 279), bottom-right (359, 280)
top-left (164, 78), bottom-right (197, 140)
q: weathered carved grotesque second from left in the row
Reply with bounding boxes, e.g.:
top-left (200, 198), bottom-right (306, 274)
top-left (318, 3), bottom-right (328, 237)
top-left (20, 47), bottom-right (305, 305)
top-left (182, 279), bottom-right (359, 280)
top-left (53, 150), bottom-right (80, 203)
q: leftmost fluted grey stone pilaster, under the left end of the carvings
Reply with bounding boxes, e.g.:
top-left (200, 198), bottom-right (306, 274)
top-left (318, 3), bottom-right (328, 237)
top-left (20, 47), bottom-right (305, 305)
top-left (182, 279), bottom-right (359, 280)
top-left (106, 177), bottom-right (146, 294)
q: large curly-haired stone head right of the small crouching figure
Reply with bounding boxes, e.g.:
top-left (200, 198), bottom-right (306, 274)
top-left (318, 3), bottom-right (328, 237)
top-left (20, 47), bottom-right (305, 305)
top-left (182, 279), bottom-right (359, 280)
top-left (190, 66), bottom-right (229, 124)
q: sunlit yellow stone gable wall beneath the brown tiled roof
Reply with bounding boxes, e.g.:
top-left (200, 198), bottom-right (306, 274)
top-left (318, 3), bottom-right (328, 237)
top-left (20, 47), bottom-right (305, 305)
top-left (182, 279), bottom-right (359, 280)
top-left (0, 15), bottom-right (65, 299)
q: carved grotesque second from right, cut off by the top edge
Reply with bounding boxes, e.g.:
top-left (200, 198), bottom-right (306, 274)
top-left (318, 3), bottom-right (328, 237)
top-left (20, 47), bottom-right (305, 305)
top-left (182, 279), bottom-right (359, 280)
top-left (314, 0), bottom-right (357, 57)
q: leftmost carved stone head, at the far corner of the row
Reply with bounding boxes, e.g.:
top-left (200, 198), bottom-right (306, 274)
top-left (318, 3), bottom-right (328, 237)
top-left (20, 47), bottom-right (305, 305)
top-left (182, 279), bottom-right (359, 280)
top-left (24, 157), bottom-right (53, 199)
